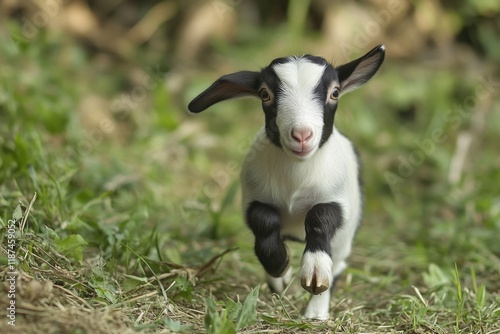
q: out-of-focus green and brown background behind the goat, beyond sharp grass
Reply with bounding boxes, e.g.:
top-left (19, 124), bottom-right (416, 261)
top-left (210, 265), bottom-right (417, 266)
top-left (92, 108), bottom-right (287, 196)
top-left (0, 0), bottom-right (500, 332)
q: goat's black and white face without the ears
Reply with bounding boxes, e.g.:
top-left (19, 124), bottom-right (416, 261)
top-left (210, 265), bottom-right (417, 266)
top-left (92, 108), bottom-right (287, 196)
top-left (258, 55), bottom-right (340, 159)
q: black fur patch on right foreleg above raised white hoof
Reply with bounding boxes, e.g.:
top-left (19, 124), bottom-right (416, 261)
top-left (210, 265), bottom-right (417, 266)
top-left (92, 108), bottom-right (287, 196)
top-left (304, 203), bottom-right (343, 256)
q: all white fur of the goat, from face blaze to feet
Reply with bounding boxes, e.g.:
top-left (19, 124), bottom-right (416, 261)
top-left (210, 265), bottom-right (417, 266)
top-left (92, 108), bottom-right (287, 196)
top-left (242, 59), bottom-right (361, 319)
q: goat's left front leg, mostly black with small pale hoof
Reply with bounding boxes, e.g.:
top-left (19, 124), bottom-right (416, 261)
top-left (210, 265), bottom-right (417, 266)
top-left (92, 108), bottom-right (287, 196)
top-left (246, 201), bottom-right (291, 292)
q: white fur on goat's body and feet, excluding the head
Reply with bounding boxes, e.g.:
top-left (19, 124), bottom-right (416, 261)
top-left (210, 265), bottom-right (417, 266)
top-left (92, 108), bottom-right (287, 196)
top-left (242, 129), bottom-right (361, 319)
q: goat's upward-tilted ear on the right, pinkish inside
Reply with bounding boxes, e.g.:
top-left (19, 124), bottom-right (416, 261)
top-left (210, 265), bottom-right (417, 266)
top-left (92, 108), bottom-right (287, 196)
top-left (336, 45), bottom-right (385, 94)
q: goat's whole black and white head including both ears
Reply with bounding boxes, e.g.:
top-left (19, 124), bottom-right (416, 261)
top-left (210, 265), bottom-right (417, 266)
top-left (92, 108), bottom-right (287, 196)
top-left (188, 45), bottom-right (385, 159)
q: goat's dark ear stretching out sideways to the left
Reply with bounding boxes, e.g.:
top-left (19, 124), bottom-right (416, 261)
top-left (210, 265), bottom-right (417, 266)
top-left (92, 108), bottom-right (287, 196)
top-left (188, 71), bottom-right (260, 113)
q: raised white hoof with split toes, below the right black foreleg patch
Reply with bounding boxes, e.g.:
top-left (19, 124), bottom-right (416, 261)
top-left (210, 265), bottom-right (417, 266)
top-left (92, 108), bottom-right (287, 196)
top-left (300, 251), bottom-right (333, 295)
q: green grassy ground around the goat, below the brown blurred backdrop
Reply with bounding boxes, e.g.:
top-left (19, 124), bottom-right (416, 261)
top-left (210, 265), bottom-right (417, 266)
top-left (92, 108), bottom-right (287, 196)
top-left (0, 11), bottom-right (500, 334)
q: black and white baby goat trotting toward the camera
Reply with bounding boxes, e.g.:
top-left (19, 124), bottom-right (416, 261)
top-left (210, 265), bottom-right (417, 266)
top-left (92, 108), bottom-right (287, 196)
top-left (188, 45), bottom-right (385, 319)
